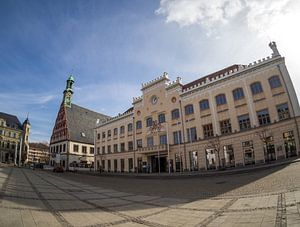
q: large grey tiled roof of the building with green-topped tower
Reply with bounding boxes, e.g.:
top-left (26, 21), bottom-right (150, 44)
top-left (66, 104), bottom-right (110, 144)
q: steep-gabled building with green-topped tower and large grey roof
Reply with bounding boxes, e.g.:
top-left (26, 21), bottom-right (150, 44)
top-left (50, 76), bottom-right (109, 169)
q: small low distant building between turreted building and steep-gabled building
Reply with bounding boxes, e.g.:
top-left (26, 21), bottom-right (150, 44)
top-left (27, 143), bottom-right (50, 164)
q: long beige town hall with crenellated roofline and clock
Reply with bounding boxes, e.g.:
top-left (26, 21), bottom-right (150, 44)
top-left (95, 42), bottom-right (300, 172)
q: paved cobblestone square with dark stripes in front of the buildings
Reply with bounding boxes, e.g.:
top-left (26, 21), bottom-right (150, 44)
top-left (0, 162), bottom-right (300, 227)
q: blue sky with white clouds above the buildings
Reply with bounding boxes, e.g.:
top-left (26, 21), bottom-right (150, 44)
top-left (0, 0), bottom-right (300, 142)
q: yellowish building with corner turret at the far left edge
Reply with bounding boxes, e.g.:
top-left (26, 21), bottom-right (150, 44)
top-left (0, 112), bottom-right (30, 164)
